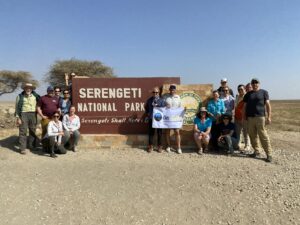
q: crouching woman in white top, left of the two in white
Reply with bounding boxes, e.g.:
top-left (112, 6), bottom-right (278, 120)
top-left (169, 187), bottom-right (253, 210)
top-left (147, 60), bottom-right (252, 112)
top-left (43, 112), bottom-right (67, 158)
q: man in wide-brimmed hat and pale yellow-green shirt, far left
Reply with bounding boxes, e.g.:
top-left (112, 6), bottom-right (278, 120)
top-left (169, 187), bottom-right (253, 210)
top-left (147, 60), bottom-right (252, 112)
top-left (15, 83), bottom-right (40, 154)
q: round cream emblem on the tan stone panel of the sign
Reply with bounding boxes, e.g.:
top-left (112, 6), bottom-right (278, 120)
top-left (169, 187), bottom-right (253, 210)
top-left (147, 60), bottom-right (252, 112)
top-left (180, 92), bottom-right (202, 125)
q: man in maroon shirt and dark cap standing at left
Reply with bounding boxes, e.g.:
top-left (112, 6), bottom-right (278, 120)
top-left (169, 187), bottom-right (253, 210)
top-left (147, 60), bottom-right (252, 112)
top-left (37, 86), bottom-right (60, 138)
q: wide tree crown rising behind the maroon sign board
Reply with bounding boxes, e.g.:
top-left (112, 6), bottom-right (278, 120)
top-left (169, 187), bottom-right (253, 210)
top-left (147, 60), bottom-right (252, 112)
top-left (45, 58), bottom-right (115, 87)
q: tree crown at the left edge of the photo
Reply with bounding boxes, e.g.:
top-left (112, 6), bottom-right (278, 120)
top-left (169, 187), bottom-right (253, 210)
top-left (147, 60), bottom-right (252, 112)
top-left (0, 70), bottom-right (38, 96)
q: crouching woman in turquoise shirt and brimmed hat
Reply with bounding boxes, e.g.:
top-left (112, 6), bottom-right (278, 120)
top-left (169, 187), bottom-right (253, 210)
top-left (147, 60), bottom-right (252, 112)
top-left (194, 107), bottom-right (212, 155)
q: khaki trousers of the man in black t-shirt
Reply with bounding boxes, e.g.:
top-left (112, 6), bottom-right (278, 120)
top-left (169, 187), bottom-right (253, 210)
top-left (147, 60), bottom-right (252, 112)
top-left (247, 117), bottom-right (272, 155)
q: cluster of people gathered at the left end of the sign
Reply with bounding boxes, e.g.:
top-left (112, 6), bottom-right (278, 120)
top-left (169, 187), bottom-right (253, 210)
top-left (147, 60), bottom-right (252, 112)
top-left (15, 73), bottom-right (80, 158)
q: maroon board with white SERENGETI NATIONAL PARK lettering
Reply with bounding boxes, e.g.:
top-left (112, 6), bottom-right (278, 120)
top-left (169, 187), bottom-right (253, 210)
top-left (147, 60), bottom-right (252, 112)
top-left (72, 77), bottom-right (180, 134)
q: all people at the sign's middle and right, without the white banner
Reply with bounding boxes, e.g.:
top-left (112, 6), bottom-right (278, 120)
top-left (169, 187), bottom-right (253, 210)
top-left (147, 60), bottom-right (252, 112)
top-left (145, 78), bottom-right (272, 162)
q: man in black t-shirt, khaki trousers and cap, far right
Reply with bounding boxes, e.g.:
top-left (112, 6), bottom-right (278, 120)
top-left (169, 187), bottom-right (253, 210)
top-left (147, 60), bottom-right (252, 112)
top-left (243, 78), bottom-right (272, 162)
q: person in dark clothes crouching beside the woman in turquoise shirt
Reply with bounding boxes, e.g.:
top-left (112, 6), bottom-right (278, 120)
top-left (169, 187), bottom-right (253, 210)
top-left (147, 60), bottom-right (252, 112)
top-left (218, 113), bottom-right (238, 154)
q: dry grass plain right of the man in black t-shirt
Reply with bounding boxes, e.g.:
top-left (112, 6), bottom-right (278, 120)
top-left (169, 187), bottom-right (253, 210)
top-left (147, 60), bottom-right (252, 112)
top-left (270, 100), bottom-right (300, 132)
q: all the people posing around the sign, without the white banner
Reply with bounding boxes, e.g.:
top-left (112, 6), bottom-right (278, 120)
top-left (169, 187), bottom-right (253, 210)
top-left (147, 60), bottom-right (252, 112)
top-left (16, 73), bottom-right (272, 162)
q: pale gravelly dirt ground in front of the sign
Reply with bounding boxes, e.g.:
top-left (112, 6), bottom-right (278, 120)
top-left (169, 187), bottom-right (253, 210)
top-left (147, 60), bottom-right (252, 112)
top-left (0, 101), bottom-right (300, 225)
